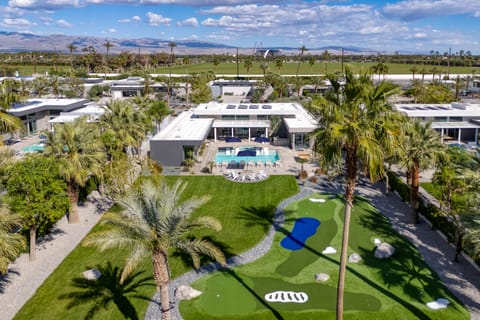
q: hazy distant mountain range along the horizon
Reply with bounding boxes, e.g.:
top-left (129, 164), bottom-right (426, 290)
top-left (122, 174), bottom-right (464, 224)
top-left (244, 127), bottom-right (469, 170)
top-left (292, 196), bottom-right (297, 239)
top-left (0, 31), bottom-right (377, 55)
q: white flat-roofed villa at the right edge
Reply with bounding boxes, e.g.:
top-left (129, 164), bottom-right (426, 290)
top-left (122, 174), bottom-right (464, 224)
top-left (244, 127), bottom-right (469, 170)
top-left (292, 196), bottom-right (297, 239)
top-left (393, 102), bottom-right (480, 145)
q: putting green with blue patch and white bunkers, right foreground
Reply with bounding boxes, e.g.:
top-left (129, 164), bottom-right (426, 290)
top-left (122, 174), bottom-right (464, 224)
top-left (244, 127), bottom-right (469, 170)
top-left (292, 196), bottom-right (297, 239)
top-left (180, 195), bottom-right (469, 320)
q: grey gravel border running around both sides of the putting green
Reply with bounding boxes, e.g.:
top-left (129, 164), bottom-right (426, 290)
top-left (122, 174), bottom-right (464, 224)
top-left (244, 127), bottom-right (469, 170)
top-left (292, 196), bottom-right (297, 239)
top-left (145, 184), bottom-right (480, 320)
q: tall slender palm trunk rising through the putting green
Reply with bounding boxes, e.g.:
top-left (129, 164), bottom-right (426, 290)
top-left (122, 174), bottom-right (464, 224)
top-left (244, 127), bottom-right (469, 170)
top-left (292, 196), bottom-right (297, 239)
top-left (337, 147), bottom-right (357, 320)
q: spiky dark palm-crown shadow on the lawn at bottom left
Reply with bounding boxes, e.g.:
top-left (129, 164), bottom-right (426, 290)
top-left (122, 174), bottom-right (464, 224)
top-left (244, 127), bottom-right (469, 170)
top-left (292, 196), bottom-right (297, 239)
top-left (59, 262), bottom-right (155, 320)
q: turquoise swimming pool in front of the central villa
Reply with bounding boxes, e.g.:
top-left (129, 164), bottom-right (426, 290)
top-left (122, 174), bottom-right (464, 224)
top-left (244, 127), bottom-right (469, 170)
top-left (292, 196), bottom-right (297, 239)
top-left (215, 146), bottom-right (280, 164)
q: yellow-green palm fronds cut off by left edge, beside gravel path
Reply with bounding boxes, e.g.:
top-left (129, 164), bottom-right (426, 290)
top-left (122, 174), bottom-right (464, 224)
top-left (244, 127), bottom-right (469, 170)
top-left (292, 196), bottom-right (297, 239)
top-left (0, 207), bottom-right (25, 275)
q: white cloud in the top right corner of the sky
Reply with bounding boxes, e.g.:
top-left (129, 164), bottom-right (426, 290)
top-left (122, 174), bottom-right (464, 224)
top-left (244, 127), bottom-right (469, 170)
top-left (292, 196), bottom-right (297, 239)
top-left (383, 0), bottom-right (480, 21)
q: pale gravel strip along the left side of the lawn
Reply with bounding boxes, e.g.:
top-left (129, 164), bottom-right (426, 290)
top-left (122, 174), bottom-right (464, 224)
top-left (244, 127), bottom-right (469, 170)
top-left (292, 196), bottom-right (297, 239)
top-left (0, 202), bottom-right (104, 320)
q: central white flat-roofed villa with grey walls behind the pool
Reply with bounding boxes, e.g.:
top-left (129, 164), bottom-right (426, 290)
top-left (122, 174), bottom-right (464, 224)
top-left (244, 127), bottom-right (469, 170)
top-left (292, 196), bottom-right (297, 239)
top-left (150, 102), bottom-right (318, 166)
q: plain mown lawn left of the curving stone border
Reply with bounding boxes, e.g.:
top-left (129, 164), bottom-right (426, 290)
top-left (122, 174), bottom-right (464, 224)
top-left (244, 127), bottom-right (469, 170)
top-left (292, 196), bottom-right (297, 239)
top-left (15, 176), bottom-right (298, 320)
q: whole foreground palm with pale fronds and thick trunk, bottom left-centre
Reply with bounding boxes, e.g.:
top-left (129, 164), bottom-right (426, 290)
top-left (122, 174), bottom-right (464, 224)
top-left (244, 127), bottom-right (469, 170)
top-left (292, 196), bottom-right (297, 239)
top-left (84, 180), bottom-right (225, 320)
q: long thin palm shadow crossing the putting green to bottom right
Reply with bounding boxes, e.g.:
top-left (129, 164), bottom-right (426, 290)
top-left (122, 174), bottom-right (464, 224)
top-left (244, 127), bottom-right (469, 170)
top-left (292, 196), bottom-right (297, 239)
top-left (237, 195), bottom-right (436, 320)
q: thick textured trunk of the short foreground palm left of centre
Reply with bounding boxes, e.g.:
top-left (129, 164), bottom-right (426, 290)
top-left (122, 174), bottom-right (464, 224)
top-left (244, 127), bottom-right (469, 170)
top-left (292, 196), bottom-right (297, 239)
top-left (152, 250), bottom-right (171, 320)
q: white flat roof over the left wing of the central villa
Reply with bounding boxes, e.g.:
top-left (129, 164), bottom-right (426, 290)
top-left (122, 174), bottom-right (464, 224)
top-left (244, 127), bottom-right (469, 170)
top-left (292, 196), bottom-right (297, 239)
top-left (151, 111), bottom-right (213, 141)
